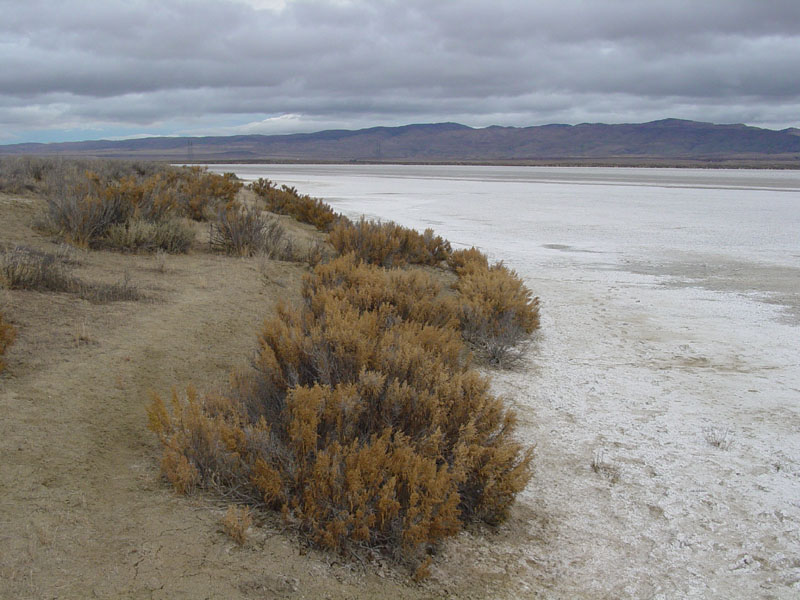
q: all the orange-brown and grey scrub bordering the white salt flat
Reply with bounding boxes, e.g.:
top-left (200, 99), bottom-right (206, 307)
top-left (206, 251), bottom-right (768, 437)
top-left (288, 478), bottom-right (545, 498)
top-left (0, 159), bottom-right (539, 577)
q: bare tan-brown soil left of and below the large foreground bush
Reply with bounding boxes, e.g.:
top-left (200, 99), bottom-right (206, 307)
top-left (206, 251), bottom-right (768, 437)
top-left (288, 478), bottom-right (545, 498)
top-left (0, 195), bottom-right (546, 599)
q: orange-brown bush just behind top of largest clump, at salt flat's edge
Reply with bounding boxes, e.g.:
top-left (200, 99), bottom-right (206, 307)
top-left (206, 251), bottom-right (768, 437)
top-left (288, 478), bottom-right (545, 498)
top-left (330, 217), bottom-right (451, 267)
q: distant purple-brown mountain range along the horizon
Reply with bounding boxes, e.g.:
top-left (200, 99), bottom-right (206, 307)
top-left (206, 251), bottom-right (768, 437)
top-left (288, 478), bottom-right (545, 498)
top-left (0, 119), bottom-right (800, 167)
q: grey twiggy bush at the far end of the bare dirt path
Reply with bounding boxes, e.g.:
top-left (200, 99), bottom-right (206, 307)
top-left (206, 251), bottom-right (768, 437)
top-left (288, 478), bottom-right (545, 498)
top-left (211, 208), bottom-right (286, 258)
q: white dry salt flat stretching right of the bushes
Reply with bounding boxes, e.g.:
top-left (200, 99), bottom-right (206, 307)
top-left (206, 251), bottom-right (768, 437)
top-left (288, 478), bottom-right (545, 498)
top-left (212, 165), bottom-right (800, 598)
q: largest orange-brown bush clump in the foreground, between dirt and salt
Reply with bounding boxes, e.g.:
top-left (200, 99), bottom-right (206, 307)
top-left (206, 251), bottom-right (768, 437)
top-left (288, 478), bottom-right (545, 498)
top-left (148, 256), bottom-right (531, 567)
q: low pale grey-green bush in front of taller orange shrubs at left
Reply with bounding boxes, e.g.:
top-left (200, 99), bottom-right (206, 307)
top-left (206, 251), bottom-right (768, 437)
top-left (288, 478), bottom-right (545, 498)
top-left (104, 219), bottom-right (195, 254)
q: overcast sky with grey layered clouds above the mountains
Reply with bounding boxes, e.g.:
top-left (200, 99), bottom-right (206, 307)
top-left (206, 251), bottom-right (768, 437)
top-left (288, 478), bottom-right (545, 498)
top-left (0, 0), bottom-right (800, 144)
